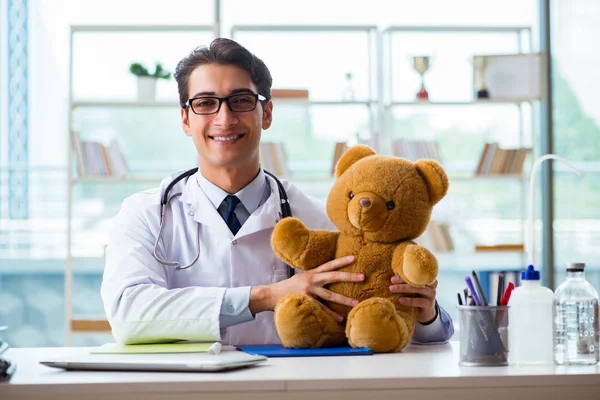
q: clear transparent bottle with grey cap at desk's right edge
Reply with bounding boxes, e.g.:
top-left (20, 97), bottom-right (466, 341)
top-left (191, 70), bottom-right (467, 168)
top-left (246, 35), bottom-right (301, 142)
top-left (554, 263), bottom-right (600, 365)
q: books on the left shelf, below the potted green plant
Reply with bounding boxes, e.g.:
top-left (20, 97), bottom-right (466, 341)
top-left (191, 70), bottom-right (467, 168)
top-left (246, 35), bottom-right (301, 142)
top-left (72, 132), bottom-right (129, 177)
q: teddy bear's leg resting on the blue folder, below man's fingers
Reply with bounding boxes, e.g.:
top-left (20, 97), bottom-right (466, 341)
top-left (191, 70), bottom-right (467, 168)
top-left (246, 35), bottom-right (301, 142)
top-left (275, 294), bottom-right (346, 348)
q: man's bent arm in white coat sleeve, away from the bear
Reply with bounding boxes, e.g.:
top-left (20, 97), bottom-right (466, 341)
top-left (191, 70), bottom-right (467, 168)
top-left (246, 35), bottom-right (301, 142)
top-left (101, 196), bottom-right (226, 343)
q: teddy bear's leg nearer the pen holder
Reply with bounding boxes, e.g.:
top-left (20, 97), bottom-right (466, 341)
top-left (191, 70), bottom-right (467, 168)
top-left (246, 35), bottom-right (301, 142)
top-left (346, 297), bottom-right (412, 353)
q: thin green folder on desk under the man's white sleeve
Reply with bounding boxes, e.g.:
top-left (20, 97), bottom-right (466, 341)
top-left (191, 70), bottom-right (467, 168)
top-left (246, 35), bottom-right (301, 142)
top-left (90, 342), bottom-right (221, 354)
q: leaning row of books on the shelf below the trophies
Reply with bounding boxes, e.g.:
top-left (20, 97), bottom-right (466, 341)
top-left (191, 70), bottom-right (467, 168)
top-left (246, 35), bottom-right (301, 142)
top-left (475, 143), bottom-right (530, 175)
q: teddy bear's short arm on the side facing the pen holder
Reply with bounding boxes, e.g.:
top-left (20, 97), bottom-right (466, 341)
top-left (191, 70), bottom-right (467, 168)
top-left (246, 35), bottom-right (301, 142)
top-left (392, 244), bottom-right (438, 286)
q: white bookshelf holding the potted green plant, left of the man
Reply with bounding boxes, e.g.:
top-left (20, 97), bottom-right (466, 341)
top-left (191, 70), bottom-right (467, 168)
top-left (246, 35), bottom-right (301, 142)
top-left (64, 25), bottom-right (218, 345)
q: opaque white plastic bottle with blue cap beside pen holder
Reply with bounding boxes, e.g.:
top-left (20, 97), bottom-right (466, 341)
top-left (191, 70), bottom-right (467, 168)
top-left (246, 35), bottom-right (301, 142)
top-left (508, 265), bottom-right (554, 365)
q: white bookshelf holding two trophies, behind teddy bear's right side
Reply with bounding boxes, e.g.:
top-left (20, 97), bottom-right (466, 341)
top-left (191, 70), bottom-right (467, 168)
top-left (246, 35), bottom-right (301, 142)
top-left (380, 26), bottom-right (541, 269)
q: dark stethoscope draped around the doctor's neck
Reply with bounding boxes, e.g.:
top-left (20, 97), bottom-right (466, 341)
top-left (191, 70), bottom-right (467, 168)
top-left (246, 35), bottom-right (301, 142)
top-left (152, 167), bottom-right (294, 276)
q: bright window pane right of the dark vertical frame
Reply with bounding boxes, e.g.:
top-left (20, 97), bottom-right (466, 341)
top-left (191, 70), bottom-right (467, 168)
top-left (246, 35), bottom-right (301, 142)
top-left (551, 0), bottom-right (600, 288)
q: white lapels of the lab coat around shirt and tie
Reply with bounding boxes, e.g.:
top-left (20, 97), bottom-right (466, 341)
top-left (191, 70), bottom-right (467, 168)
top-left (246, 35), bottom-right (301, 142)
top-left (179, 170), bottom-right (282, 238)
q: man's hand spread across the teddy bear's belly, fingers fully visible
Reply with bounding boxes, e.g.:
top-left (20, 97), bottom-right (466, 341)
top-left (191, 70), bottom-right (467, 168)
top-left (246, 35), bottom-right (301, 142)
top-left (250, 256), bottom-right (365, 322)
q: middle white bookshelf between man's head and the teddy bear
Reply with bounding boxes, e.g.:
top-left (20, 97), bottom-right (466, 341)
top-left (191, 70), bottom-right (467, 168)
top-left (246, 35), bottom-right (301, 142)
top-left (230, 24), bottom-right (381, 200)
